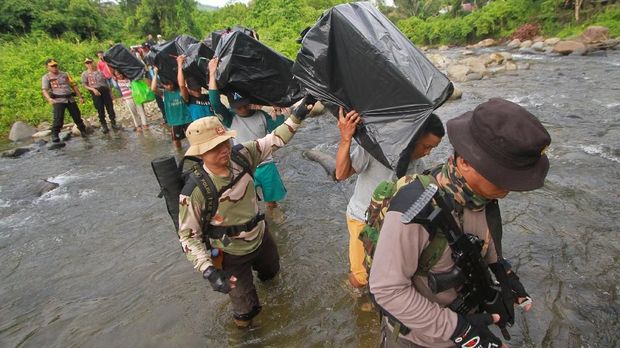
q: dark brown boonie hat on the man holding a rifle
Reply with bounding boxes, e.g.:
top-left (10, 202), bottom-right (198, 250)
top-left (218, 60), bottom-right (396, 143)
top-left (447, 98), bottom-right (551, 191)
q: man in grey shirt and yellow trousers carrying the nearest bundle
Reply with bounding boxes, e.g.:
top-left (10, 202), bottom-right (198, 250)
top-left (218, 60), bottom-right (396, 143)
top-left (335, 108), bottom-right (446, 288)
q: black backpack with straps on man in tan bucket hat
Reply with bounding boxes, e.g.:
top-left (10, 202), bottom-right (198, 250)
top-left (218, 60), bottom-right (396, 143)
top-left (151, 144), bottom-right (253, 232)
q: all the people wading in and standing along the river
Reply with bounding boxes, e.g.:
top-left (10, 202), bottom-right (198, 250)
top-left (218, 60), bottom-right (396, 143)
top-left (42, 36), bottom-right (551, 348)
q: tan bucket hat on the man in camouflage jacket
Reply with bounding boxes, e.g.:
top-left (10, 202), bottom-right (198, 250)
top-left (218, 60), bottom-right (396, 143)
top-left (185, 116), bottom-right (237, 156)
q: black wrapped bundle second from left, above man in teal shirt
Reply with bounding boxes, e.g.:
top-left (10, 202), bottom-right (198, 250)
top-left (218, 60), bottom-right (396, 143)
top-left (151, 35), bottom-right (198, 83)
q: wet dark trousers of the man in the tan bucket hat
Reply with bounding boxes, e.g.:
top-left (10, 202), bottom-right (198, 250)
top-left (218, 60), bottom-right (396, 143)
top-left (222, 225), bottom-right (280, 321)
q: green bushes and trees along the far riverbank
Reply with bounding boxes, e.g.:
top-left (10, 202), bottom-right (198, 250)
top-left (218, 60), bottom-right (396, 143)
top-left (0, 0), bottom-right (620, 134)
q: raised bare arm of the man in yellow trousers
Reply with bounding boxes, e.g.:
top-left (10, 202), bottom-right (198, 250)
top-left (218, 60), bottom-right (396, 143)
top-left (336, 107), bottom-right (362, 181)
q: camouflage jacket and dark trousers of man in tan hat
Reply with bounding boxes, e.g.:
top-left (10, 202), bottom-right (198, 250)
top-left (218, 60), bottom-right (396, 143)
top-left (179, 117), bottom-right (299, 320)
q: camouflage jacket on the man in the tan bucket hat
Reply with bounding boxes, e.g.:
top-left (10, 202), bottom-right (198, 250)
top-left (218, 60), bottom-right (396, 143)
top-left (179, 117), bottom-right (299, 272)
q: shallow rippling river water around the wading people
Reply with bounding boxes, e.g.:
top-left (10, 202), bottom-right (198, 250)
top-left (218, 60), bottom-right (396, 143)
top-left (0, 51), bottom-right (620, 347)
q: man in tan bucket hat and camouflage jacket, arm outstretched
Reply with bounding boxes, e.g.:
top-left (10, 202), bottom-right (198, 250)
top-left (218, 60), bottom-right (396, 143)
top-left (179, 100), bottom-right (311, 327)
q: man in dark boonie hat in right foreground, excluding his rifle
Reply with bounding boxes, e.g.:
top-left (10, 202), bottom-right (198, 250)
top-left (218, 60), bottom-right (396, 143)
top-left (370, 98), bottom-right (551, 348)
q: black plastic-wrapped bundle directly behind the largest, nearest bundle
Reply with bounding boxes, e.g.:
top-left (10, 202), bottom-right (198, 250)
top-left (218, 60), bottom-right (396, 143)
top-left (215, 31), bottom-right (303, 107)
